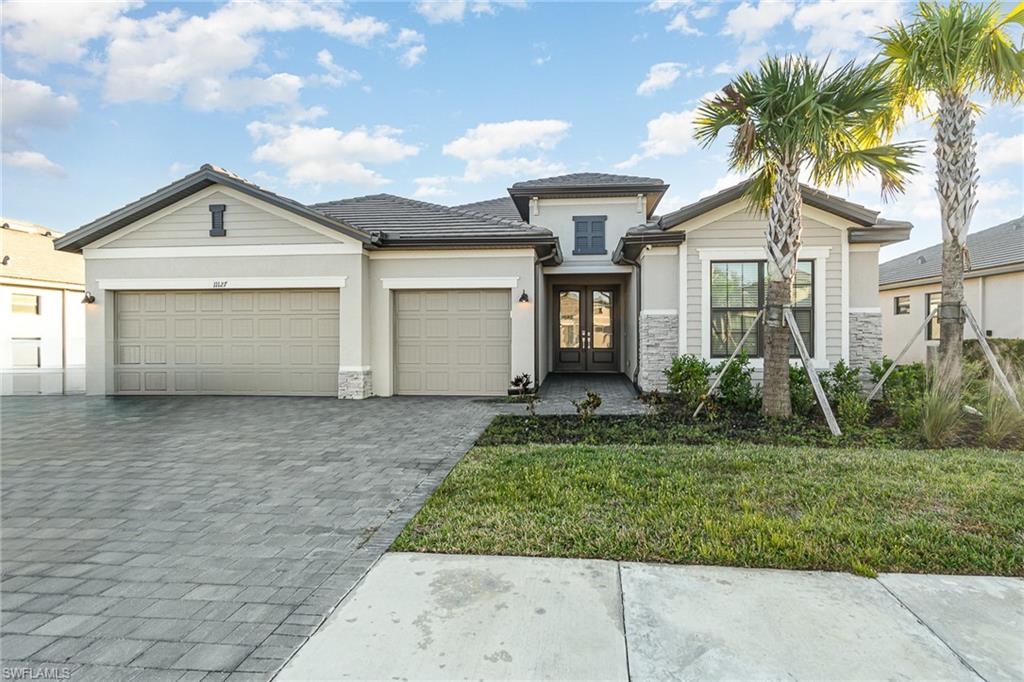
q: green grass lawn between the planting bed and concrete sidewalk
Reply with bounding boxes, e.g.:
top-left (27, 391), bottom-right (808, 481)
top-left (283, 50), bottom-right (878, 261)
top-left (393, 444), bottom-right (1024, 576)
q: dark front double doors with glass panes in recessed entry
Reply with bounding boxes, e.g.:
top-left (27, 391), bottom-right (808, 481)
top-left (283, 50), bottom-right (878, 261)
top-left (554, 285), bottom-right (620, 372)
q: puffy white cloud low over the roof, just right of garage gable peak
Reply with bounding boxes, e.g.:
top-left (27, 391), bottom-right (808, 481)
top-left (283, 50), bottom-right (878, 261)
top-left (247, 121), bottom-right (420, 185)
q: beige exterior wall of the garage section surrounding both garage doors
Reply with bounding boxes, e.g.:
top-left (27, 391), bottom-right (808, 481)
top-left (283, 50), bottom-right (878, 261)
top-left (85, 187), bottom-right (536, 395)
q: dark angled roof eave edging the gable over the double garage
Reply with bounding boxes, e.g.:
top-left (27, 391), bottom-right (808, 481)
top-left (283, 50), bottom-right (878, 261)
top-left (53, 167), bottom-right (370, 253)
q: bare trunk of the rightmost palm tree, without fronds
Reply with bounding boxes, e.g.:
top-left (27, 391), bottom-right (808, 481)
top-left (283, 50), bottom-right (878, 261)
top-left (935, 94), bottom-right (978, 386)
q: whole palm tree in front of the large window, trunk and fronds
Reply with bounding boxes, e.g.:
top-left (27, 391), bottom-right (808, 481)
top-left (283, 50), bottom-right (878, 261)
top-left (694, 56), bottom-right (918, 417)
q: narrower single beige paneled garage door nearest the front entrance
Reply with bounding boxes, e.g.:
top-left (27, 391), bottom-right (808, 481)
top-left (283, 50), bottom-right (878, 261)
top-left (394, 289), bottom-right (512, 395)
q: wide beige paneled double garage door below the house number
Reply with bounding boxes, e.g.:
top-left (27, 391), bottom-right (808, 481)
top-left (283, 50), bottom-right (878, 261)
top-left (114, 289), bottom-right (339, 395)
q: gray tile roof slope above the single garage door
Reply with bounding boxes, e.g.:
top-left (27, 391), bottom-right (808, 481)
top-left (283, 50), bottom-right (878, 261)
top-left (309, 195), bottom-right (553, 244)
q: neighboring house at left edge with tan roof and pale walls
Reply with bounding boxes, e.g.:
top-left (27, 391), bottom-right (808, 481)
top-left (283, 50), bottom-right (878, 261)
top-left (0, 218), bottom-right (85, 395)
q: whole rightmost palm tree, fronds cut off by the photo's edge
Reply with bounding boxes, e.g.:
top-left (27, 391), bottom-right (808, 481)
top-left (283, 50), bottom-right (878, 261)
top-left (878, 0), bottom-right (1024, 386)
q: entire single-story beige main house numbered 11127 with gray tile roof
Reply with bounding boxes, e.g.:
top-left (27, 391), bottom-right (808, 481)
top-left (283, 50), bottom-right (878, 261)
top-left (51, 165), bottom-right (910, 398)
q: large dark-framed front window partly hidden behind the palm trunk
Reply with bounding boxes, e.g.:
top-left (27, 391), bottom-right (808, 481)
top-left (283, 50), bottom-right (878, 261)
top-left (711, 260), bottom-right (814, 357)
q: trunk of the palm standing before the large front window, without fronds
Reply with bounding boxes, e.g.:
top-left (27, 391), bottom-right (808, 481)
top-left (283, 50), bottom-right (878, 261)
top-left (761, 163), bottom-right (801, 418)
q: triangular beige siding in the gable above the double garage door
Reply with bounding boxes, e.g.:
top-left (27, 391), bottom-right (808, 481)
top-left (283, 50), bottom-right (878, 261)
top-left (104, 190), bottom-right (337, 249)
